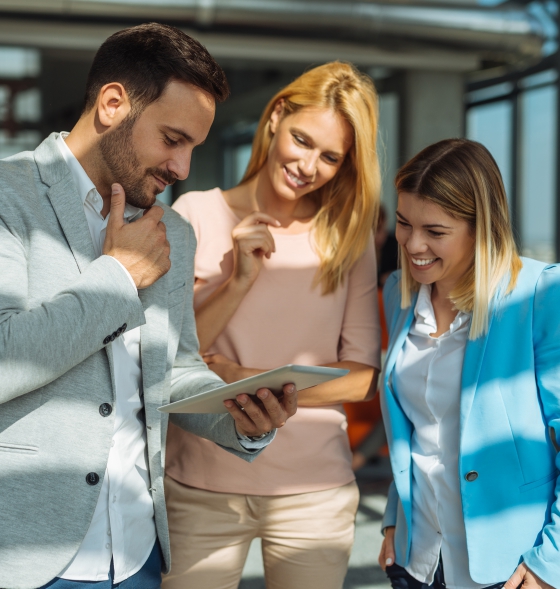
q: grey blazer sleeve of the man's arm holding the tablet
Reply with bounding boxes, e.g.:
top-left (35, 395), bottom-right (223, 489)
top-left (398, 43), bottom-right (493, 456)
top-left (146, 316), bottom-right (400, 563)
top-left (170, 221), bottom-right (275, 462)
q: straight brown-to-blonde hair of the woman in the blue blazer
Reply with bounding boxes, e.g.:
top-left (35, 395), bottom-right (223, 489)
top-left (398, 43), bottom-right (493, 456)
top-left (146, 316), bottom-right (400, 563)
top-left (395, 139), bottom-right (522, 339)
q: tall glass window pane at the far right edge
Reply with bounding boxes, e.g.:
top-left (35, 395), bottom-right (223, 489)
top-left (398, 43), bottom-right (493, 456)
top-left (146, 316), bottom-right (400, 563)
top-left (519, 86), bottom-right (557, 262)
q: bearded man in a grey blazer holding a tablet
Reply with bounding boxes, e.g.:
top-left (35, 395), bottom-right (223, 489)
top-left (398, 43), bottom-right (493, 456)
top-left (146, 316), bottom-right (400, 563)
top-left (0, 23), bottom-right (296, 589)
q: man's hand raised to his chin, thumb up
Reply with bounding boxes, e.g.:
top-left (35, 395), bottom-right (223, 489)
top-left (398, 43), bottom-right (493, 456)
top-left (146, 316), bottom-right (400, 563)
top-left (103, 184), bottom-right (171, 289)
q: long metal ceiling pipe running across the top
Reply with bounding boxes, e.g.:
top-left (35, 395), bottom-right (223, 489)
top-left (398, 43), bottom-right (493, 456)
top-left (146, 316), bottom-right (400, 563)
top-left (0, 0), bottom-right (547, 56)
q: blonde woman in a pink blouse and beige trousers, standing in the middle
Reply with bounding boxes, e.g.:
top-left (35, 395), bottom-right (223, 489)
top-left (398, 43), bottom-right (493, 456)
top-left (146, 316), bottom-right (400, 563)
top-left (164, 62), bottom-right (380, 589)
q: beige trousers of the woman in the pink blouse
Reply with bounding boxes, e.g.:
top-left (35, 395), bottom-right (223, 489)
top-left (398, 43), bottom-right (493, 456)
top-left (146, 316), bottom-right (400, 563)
top-left (163, 477), bottom-right (359, 589)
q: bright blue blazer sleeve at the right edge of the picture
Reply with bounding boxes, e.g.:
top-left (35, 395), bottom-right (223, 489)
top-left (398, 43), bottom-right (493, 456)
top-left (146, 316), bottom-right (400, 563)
top-left (523, 265), bottom-right (560, 587)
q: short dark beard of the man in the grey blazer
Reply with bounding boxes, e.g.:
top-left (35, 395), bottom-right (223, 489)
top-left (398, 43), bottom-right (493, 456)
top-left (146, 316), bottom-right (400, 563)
top-left (99, 113), bottom-right (176, 209)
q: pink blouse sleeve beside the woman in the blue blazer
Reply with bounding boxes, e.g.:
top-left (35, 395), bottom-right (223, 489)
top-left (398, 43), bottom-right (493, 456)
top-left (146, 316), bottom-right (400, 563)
top-left (338, 235), bottom-right (381, 368)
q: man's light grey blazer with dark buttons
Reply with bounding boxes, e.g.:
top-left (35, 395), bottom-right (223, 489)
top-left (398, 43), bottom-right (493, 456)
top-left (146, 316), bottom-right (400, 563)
top-left (0, 134), bottom-right (264, 589)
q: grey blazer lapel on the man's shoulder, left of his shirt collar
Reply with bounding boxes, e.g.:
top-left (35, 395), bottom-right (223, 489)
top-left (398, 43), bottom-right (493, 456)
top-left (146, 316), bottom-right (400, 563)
top-left (34, 133), bottom-right (96, 272)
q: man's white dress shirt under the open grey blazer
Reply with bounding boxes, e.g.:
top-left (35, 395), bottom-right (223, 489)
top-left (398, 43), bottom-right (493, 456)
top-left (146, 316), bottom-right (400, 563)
top-left (57, 134), bottom-right (156, 583)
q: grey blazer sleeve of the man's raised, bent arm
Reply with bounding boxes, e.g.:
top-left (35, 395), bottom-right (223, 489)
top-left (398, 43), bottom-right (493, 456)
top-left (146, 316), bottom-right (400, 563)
top-left (0, 216), bottom-right (145, 404)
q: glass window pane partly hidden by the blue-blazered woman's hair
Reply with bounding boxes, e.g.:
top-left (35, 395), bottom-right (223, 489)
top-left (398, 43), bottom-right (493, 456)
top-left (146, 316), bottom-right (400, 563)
top-left (467, 100), bottom-right (513, 207)
